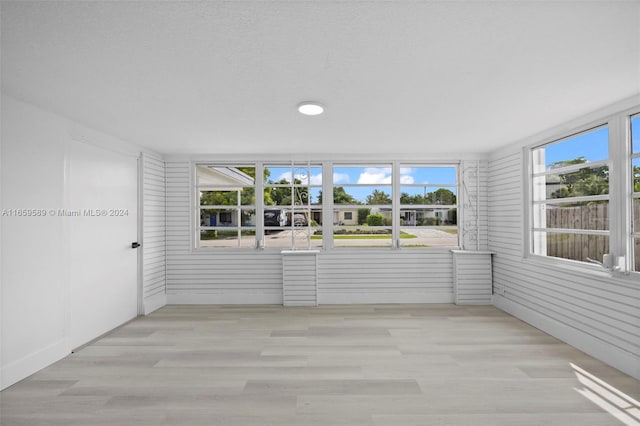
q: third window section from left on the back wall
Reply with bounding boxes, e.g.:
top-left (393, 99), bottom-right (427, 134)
top-left (333, 164), bottom-right (393, 247)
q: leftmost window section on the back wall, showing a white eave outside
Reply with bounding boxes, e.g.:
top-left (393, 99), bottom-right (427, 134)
top-left (195, 164), bottom-right (256, 248)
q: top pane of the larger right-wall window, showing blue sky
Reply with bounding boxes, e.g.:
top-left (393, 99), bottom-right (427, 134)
top-left (533, 127), bottom-right (609, 172)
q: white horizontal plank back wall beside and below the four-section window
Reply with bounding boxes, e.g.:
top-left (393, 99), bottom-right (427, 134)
top-left (166, 160), bottom-right (487, 304)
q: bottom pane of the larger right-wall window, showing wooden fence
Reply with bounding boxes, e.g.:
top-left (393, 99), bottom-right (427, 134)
top-left (533, 232), bottom-right (609, 263)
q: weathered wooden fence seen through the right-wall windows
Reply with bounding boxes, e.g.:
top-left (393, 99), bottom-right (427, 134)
top-left (547, 199), bottom-right (640, 271)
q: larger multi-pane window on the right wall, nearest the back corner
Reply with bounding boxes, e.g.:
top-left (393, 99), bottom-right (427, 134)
top-left (531, 126), bottom-right (609, 262)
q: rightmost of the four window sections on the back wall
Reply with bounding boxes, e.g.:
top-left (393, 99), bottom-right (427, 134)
top-left (400, 164), bottom-right (459, 247)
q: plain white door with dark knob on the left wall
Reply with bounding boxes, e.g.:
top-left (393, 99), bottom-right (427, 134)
top-left (65, 141), bottom-right (138, 349)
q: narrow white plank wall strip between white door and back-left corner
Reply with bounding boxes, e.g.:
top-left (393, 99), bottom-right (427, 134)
top-left (141, 153), bottom-right (166, 314)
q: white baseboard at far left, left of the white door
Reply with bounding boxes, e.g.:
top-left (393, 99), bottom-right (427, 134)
top-left (0, 339), bottom-right (69, 390)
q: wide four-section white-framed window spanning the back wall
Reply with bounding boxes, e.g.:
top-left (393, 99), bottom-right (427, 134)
top-left (193, 161), bottom-right (459, 250)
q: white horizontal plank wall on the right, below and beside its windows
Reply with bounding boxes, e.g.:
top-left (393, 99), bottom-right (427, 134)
top-left (489, 148), bottom-right (640, 377)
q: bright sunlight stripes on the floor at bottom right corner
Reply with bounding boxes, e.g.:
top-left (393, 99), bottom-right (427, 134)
top-left (570, 363), bottom-right (640, 426)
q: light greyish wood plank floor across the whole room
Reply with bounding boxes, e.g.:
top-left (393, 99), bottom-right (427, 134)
top-left (0, 305), bottom-right (640, 426)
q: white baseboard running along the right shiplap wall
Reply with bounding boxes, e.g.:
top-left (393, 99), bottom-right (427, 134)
top-left (493, 295), bottom-right (640, 379)
